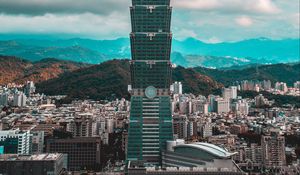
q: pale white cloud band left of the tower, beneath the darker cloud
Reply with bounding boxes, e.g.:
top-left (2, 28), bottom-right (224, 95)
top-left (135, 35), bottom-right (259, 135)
top-left (0, 13), bottom-right (130, 38)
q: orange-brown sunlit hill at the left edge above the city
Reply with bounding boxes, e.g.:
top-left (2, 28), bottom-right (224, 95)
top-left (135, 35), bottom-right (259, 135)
top-left (0, 55), bottom-right (88, 85)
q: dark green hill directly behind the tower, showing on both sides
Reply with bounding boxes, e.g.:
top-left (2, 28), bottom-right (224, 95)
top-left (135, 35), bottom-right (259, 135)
top-left (37, 60), bottom-right (222, 100)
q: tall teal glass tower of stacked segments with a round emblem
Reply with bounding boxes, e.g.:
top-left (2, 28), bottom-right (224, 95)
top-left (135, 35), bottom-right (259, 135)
top-left (127, 0), bottom-right (173, 165)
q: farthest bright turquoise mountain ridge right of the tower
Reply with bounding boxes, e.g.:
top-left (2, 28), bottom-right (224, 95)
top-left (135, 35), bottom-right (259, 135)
top-left (173, 38), bottom-right (300, 61)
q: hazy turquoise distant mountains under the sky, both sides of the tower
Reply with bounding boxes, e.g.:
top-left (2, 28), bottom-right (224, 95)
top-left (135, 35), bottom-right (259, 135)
top-left (0, 36), bottom-right (300, 68)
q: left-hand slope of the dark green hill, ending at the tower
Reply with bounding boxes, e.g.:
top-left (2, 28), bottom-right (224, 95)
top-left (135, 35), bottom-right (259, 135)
top-left (37, 60), bottom-right (130, 99)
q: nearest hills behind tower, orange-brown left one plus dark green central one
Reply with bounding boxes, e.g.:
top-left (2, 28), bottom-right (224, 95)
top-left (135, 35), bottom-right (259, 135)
top-left (0, 56), bottom-right (222, 100)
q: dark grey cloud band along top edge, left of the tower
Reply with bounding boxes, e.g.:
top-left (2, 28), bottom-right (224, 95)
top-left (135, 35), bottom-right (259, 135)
top-left (0, 0), bottom-right (130, 15)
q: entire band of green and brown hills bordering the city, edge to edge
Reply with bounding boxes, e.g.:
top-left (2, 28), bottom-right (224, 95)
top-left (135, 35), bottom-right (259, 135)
top-left (0, 56), bottom-right (300, 100)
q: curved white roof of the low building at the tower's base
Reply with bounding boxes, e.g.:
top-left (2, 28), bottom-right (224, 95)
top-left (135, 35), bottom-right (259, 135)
top-left (174, 142), bottom-right (236, 158)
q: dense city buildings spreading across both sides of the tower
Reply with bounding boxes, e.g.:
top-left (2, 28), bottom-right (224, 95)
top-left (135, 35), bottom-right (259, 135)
top-left (0, 81), bottom-right (300, 174)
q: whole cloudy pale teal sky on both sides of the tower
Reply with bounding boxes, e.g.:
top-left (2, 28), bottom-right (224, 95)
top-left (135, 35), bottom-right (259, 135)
top-left (0, 0), bottom-right (300, 43)
